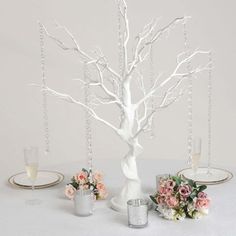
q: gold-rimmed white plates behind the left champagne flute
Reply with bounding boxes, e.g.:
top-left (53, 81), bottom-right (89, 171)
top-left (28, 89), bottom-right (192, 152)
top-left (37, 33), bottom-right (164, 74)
top-left (8, 170), bottom-right (64, 189)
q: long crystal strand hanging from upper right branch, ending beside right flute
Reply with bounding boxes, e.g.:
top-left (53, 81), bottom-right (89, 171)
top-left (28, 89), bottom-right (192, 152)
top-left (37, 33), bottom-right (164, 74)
top-left (183, 22), bottom-right (193, 165)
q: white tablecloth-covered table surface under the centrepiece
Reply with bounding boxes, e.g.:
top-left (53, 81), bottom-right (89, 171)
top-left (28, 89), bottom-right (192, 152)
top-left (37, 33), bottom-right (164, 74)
top-left (0, 159), bottom-right (236, 236)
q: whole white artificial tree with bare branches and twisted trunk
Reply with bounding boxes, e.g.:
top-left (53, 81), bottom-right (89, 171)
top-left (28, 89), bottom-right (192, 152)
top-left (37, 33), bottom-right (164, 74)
top-left (43, 0), bottom-right (208, 211)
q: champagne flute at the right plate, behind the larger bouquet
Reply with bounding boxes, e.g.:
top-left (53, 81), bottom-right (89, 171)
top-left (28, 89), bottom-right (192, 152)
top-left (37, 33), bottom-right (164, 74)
top-left (191, 137), bottom-right (202, 175)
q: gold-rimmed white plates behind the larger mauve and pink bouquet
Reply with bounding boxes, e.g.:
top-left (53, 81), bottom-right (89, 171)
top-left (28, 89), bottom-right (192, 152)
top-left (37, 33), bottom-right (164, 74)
top-left (177, 167), bottom-right (233, 185)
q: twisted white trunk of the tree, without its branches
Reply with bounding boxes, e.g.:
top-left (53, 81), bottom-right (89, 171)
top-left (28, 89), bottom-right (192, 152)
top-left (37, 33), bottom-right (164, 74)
top-left (111, 80), bottom-right (143, 212)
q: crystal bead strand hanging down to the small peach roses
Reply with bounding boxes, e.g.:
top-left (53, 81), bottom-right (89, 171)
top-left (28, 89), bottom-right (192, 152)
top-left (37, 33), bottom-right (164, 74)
top-left (84, 62), bottom-right (93, 183)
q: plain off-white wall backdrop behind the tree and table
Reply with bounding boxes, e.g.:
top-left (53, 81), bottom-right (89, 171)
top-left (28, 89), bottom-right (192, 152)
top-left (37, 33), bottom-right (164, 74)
top-left (0, 0), bottom-right (236, 169)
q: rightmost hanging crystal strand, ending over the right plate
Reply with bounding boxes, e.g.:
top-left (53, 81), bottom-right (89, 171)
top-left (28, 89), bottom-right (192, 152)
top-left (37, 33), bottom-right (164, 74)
top-left (207, 52), bottom-right (213, 174)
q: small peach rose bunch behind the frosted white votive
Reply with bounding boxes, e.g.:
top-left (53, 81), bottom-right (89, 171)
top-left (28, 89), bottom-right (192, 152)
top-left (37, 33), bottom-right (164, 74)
top-left (65, 168), bottom-right (107, 200)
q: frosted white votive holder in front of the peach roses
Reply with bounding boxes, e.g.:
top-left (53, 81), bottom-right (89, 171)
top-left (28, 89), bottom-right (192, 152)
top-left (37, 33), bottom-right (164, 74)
top-left (74, 189), bottom-right (94, 216)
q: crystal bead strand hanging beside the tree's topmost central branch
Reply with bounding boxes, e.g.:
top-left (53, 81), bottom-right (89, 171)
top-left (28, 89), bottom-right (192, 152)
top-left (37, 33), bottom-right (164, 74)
top-left (117, 0), bottom-right (124, 120)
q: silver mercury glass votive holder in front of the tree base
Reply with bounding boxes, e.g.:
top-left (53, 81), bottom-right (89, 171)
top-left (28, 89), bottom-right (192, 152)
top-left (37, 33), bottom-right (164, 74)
top-left (127, 199), bottom-right (148, 228)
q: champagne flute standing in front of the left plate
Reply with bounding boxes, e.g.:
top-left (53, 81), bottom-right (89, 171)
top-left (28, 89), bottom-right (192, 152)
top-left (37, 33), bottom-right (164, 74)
top-left (24, 147), bottom-right (41, 205)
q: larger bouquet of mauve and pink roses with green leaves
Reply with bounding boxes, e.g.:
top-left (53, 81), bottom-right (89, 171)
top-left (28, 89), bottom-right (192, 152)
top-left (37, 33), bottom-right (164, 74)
top-left (150, 176), bottom-right (210, 220)
